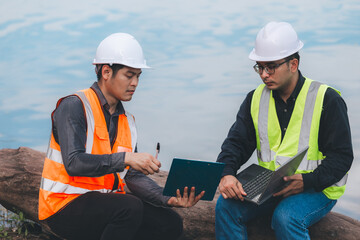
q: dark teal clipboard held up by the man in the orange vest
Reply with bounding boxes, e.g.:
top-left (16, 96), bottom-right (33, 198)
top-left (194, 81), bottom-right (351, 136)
top-left (163, 158), bottom-right (225, 201)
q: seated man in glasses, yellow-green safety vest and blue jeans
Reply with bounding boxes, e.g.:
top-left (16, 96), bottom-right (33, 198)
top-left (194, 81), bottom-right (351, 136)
top-left (215, 22), bottom-right (353, 240)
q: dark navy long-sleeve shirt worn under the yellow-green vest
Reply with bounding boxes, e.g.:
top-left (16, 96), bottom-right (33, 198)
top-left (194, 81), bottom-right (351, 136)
top-left (217, 71), bottom-right (353, 191)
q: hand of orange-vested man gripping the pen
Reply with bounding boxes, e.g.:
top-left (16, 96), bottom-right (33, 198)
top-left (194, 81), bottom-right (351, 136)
top-left (125, 152), bottom-right (161, 175)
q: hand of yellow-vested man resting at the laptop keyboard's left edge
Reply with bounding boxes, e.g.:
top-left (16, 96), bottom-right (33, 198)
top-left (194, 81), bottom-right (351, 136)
top-left (219, 175), bottom-right (246, 201)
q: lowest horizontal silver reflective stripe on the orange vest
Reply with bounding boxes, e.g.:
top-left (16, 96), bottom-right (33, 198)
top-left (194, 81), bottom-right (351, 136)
top-left (40, 178), bottom-right (111, 194)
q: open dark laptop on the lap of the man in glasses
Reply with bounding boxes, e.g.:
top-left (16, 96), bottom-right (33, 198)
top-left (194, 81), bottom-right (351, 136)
top-left (236, 147), bottom-right (308, 205)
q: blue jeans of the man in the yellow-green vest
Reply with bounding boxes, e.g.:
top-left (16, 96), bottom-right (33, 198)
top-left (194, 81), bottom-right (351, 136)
top-left (215, 190), bottom-right (336, 240)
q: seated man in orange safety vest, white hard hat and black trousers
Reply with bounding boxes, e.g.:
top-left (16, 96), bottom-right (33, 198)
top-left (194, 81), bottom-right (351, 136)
top-left (39, 33), bottom-right (204, 240)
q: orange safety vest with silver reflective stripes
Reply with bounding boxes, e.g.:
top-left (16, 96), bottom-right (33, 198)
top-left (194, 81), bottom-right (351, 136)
top-left (39, 88), bottom-right (137, 220)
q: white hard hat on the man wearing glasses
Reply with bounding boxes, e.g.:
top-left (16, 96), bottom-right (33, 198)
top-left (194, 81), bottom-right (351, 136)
top-left (249, 22), bottom-right (304, 62)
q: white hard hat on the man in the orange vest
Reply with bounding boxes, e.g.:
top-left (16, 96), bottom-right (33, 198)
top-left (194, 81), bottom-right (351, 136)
top-left (93, 33), bottom-right (150, 68)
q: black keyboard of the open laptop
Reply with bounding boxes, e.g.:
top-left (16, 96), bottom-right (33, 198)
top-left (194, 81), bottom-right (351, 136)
top-left (243, 169), bottom-right (273, 200)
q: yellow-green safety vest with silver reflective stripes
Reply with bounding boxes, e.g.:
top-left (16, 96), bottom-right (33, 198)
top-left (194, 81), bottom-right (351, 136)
top-left (251, 78), bottom-right (348, 199)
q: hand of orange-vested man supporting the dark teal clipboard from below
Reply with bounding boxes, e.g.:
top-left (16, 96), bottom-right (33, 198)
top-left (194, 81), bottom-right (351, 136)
top-left (167, 187), bottom-right (205, 208)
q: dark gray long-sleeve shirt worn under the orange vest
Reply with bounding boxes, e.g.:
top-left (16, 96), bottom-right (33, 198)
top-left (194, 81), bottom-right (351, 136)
top-left (52, 82), bottom-right (170, 206)
